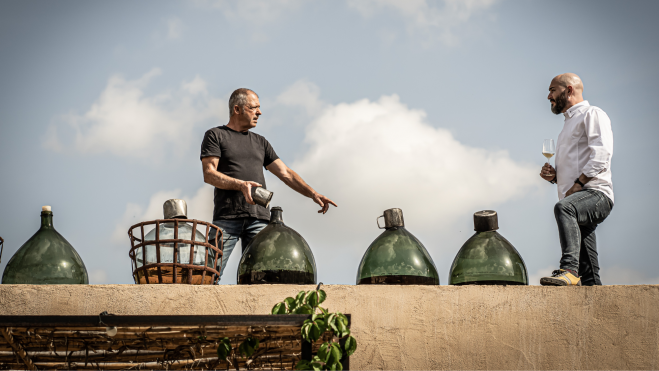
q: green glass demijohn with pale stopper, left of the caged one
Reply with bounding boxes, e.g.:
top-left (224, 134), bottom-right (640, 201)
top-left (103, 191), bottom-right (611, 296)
top-left (2, 206), bottom-right (89, 285)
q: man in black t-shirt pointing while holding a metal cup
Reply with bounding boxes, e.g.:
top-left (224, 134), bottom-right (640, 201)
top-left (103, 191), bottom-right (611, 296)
top-left (200, 89), bottom-right (337, 282)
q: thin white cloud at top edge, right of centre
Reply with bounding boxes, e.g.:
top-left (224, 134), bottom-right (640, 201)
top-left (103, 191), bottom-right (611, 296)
top-left (347, 0), bottom-right (496, 45)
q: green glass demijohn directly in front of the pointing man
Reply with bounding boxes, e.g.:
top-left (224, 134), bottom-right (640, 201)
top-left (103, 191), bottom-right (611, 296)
top-left (238, 207), bottom-right (316, 285)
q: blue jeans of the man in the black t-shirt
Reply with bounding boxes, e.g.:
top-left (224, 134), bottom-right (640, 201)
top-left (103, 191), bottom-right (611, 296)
top-left (209, 218), bottom-right (268, 280)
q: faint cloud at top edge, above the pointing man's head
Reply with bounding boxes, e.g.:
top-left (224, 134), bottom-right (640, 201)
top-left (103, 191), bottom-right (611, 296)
top-left (196, 0), bottom-right (303, 24)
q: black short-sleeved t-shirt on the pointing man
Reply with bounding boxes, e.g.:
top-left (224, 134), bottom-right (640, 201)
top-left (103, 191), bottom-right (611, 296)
top-left (200, 125), bottom-right (279, 220)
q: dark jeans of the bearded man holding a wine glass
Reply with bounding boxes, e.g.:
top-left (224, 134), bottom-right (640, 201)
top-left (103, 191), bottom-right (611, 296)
top-left (554, 189), bottom-right (613, 286)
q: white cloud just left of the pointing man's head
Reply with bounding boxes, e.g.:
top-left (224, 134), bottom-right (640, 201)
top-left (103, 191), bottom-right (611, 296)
top-left (43, 68), bottom-right (227, 161)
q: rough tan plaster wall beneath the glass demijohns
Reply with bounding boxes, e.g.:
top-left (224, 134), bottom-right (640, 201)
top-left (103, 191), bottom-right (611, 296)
top-left (0, 285), bottom-right (659, 370)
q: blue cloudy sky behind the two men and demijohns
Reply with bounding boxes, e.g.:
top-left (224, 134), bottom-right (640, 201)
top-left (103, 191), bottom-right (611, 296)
top-left (0, 0), bottom-right (659, 284)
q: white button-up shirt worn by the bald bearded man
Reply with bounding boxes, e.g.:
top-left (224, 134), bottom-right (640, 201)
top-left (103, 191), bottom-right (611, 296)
top-left (555, 100), bottom-right (613, 202)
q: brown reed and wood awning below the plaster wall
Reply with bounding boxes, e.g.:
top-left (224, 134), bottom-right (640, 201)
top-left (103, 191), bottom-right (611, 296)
top-left (0, 315), bottom-right (349, 370)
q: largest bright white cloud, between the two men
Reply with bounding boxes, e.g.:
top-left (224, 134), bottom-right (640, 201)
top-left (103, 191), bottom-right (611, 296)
top-left (274, 88), bottom-right (539, 228)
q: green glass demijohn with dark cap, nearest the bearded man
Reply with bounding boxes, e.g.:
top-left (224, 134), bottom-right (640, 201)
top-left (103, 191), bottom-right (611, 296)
top-left (449, 210), bottom-right (529, 285)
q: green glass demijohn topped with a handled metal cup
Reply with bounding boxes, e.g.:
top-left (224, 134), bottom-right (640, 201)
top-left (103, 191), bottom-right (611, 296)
top-left (357, 209), bottom-right (439, 285)
